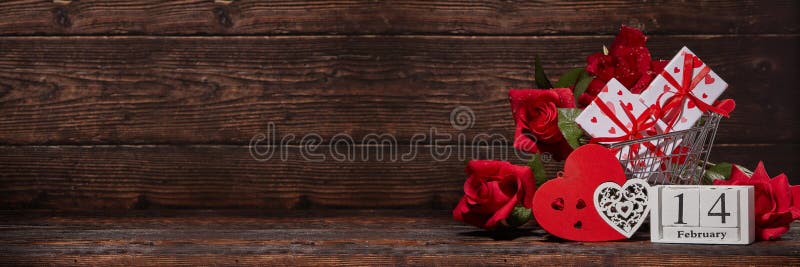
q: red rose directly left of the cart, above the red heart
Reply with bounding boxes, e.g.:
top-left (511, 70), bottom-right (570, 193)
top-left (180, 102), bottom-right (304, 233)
top-left (508, 88), bottom-right (575, 160)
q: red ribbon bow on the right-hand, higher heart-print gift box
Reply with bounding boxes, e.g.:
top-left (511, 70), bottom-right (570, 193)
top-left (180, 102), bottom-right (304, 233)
top-left (656, 53), bottom-right (729, 132)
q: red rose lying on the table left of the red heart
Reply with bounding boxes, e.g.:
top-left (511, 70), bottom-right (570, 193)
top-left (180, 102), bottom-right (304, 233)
top-left (453, 160), bottom-right (536, 230)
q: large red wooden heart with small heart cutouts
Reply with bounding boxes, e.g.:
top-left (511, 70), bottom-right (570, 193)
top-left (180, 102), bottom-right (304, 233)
top-left (533, 144), bottom-right (626, 241)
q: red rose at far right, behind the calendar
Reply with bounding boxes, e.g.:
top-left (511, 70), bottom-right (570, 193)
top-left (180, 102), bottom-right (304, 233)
top-left (714, 162), bottom-right (800, 240)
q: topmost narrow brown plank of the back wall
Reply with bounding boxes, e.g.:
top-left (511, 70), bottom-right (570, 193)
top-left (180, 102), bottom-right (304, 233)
top-left (0, 0), bottom-right (798, 35)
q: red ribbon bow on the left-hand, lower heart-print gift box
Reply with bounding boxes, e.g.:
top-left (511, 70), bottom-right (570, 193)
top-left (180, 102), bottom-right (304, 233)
top-left (590, 98), bottom-right (664, 160)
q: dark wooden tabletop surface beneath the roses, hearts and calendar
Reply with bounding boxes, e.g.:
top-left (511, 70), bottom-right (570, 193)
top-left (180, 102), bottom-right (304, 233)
top-left (0, 210), bottom-right (800, 266)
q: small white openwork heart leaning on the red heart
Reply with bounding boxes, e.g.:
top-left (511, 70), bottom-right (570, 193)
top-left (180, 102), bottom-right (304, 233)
top-left (594, 179), bottom-right (650, 238)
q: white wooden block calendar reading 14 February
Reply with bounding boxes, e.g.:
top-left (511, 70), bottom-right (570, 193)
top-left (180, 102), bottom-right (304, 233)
top-left (649, 185), bottom-right (755, 244)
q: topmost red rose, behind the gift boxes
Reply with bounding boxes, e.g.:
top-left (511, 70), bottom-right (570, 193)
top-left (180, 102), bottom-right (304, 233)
top-left (579, 26), bottom-right (668, 105)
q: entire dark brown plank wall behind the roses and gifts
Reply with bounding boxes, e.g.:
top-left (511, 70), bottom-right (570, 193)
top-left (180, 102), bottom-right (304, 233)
top-left (0, 0), bottom-right (800, 211)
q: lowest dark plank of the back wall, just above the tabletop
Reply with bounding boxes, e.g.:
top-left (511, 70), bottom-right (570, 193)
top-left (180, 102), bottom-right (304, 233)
top-left (0, 145), bottom-right (800, 210)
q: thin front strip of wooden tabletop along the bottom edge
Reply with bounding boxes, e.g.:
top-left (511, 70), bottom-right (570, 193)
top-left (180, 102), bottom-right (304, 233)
top-left (0, 255), bottom-right (800, 266)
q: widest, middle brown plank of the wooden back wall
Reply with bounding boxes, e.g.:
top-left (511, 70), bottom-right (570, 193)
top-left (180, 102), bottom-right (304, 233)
top-left (0, 36), bottom-right (800, 145)
